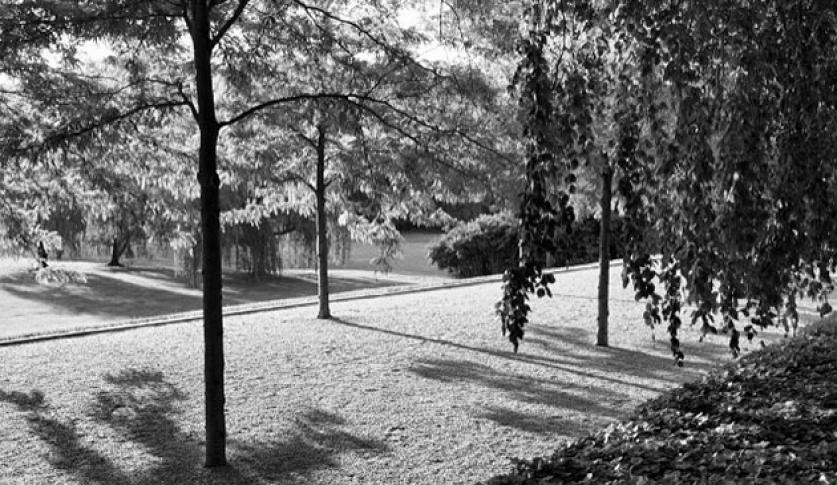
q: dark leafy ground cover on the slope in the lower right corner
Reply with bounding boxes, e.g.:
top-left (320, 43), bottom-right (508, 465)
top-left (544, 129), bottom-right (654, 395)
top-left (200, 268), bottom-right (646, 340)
top-left (488, 318), bottom-right (837, 485)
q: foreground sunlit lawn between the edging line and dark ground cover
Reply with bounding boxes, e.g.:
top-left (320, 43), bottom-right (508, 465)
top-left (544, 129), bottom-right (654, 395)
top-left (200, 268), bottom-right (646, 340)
top-left (0, 268), bottom-right (800, 484)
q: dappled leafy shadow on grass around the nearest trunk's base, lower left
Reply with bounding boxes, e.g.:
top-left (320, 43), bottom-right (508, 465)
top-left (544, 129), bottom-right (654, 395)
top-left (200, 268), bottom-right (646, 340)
top-left (0, 369), bottom-right (386, 485)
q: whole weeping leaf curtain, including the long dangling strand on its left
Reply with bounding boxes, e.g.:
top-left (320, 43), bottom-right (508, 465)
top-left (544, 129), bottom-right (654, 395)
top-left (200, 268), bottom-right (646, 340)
top-left (499, 0), bottom-right (837, 365)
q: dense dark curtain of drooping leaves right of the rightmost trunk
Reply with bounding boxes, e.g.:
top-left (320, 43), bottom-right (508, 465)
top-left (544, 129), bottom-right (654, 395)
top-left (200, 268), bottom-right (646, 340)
top-left (619, 0), bottom-right (837, 362)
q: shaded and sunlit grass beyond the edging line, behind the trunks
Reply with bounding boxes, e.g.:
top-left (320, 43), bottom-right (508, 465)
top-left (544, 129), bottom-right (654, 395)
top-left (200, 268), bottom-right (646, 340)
top-left (0, 233), bottom-right (449, 339)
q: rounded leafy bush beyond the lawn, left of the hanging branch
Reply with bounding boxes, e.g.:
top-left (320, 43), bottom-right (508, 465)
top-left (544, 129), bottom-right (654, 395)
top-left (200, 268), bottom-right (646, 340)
top-left (428, 212), bottom-right (518, 278)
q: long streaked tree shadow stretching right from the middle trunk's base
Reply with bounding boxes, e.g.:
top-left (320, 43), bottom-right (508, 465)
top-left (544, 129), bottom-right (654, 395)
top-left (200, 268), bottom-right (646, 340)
top-left (330, 318), bottom-right (728, 435)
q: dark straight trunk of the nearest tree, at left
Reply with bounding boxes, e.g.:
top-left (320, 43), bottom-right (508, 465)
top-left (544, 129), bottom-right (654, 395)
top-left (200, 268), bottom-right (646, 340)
top-left (191, 0), bottom-right (227, 467)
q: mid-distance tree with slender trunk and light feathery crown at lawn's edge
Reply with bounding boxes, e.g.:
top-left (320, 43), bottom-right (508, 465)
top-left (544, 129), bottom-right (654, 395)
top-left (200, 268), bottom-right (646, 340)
top-left (212, 1), bottom-right (516, 318)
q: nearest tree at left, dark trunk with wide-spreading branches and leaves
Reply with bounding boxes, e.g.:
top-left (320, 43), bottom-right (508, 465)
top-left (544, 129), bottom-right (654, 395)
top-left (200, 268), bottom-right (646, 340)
top-left (0, 0), bottom-right (524, 467)
